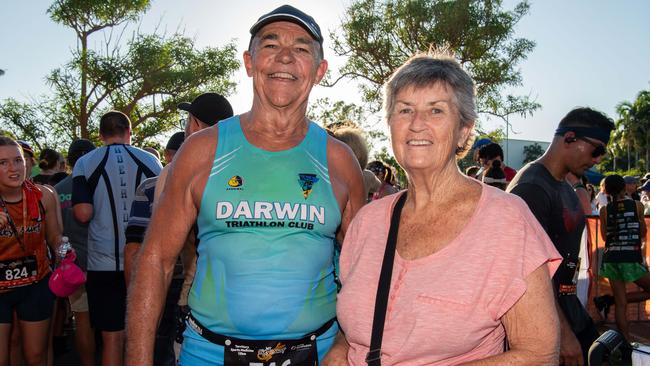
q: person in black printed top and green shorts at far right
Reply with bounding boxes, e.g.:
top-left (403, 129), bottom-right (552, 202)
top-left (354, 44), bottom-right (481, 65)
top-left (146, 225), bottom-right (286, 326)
top-left (596, 174), bottom-right (650, 341)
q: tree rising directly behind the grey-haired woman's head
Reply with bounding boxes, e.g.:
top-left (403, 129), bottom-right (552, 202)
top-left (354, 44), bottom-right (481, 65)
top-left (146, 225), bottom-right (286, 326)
top-left (324, 0), bottom-right (540, 119)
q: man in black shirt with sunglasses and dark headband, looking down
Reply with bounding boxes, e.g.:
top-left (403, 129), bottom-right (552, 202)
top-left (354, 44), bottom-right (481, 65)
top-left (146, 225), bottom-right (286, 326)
top-left (508, 108), bottom-right (614, 365)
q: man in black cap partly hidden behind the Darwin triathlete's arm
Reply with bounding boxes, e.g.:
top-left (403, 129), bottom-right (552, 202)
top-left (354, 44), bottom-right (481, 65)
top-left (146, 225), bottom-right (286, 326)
top-left (124, 93), bottom-right (233, 365)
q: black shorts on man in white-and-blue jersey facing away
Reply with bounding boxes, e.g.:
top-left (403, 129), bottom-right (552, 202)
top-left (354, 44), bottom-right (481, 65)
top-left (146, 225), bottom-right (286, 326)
top-left (86, 271), bottom-right (126, 332)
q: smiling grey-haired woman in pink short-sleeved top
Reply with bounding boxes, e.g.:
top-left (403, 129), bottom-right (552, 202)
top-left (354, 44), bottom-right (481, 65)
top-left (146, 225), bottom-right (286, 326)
top-left (324, 55), bottom-right (560, 365)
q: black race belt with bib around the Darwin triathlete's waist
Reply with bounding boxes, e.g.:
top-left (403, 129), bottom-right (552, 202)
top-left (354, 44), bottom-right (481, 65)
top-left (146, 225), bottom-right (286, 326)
top-left (187, 312), bottom-right (336, 366)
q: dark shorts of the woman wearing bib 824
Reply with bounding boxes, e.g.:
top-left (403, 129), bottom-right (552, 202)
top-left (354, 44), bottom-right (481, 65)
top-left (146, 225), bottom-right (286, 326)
top-left (0, 274), bottom-right (56, 324)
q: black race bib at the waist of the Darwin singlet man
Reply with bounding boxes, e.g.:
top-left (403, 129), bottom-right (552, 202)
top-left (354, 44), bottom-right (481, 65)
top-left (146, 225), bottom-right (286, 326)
top-left (224, 335), bottom-right (318, 366)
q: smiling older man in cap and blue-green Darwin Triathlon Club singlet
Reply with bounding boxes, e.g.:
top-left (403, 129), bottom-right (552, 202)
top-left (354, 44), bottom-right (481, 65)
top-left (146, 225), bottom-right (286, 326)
top-left (127, 5), bottom-right (364, 365)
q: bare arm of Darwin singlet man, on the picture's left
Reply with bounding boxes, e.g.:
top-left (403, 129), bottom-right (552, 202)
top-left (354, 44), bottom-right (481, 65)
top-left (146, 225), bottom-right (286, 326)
top-left (126, 128), bottom-right (217, 365)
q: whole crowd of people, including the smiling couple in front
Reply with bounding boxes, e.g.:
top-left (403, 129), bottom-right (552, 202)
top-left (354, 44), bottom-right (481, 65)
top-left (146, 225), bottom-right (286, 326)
top-left (0, 5), bottom-right (650, 366)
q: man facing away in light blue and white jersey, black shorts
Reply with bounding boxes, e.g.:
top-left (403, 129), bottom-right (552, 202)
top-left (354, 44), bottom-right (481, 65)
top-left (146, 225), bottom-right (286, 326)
top-left (72, 111), bottom-right (162, 365)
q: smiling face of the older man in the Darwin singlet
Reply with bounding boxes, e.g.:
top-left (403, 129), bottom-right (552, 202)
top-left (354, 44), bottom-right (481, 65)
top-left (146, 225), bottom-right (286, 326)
top-left (244, 22), bottom-right (327, 108)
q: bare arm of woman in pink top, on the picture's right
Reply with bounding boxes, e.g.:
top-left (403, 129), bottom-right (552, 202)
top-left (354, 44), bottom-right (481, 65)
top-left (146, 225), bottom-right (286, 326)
top-left (464, 265), bottom-right (560, 366)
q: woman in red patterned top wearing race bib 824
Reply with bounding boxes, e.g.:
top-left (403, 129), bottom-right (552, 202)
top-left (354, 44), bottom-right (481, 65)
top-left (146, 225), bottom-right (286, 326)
top-left (0, 136), bottom-right (61, 365)
